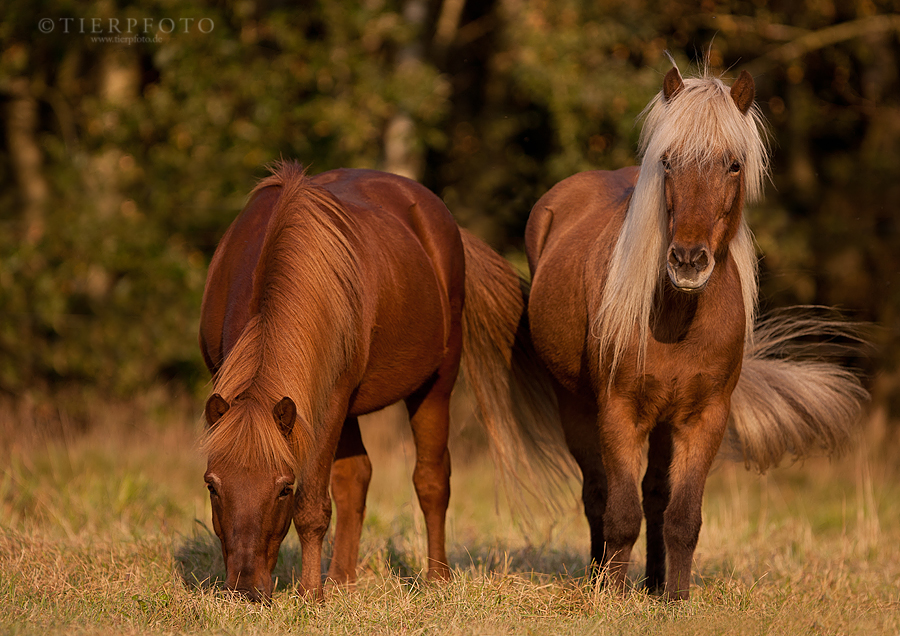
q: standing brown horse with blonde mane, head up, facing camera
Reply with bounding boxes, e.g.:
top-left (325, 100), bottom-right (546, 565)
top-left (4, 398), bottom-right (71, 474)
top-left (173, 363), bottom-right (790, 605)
top-left (526, 68), bottom-right (865, 599)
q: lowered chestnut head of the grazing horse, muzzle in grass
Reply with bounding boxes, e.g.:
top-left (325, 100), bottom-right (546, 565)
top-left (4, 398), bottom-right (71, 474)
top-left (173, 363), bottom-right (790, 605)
top-left (205, 394), bottom-right (297, 601)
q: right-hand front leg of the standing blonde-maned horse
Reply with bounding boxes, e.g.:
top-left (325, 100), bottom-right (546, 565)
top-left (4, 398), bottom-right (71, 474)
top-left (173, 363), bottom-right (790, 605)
top-left (663, 399), bottom-right (729, 600)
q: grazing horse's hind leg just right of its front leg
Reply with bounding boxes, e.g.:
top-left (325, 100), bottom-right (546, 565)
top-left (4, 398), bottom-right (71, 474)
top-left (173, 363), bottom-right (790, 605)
top-left (328, 417), bottom-right (372, 584)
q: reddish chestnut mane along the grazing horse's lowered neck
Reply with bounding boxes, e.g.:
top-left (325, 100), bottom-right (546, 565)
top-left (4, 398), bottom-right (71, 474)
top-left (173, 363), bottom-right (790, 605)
top-left (203, 163), bottom-right (361, 468)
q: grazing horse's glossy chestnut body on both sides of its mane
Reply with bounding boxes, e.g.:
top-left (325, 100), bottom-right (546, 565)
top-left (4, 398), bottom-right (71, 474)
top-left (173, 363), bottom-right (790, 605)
top-left (200, 169), bottom-right (465, 415)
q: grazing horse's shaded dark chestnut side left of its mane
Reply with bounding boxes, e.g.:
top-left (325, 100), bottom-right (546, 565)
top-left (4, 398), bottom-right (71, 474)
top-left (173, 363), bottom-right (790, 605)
top-left (200, 187), bottom-right (281, 374)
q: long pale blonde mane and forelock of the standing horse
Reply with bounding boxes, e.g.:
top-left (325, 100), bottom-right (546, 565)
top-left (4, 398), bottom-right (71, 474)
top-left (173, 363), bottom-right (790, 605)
top-left (592, 73), bottom-right (768, 380)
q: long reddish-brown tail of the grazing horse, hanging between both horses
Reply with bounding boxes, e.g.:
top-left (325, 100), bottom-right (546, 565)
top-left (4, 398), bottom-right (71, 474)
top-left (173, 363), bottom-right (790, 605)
top-left (460, 230), bottom-right (573, 503)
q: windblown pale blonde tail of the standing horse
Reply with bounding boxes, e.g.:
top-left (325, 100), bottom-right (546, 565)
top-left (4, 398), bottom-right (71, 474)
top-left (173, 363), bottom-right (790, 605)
top-left (728, 312), bottom-right (869, 472)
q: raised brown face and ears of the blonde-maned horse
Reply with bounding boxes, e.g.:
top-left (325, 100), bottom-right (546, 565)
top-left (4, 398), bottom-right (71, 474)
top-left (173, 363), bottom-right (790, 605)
top-left (659, 68), bottom-right (755, 293)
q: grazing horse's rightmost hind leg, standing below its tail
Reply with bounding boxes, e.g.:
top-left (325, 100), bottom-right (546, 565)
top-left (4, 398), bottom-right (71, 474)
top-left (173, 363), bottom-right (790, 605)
top-left (406, 374), bottom-right (455, 580)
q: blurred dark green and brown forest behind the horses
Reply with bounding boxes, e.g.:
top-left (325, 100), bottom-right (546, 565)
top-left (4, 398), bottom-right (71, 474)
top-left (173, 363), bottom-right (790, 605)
top-left (0, 0), bottom-right (900, 428)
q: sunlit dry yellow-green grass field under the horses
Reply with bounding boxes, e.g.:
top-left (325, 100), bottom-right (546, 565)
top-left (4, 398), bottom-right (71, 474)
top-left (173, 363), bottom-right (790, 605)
top-left (0, 395), bottom-right (900, 636)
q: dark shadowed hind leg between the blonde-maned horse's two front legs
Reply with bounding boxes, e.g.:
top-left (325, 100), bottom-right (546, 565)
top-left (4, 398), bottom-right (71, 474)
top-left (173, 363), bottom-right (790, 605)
top-left (641, 423), bottom-right (672, 593)
